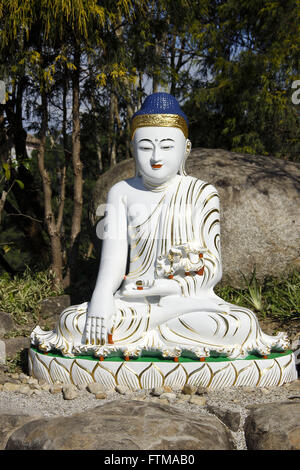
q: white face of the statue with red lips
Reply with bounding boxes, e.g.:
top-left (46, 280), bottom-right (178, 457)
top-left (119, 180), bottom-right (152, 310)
top-left (132, 127), bottom-right (187, 183)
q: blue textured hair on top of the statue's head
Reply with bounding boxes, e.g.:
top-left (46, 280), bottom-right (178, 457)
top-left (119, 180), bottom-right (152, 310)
top-left (132, 92), bottom-right (189, 125)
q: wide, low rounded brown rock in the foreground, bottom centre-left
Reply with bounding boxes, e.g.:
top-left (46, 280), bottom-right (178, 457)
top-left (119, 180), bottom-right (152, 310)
top-left (6, 399), bottom-right (234, 451)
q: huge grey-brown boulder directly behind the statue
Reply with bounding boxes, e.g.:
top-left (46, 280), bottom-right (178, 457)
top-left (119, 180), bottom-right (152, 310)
top-left (90, 148), bottom-right (300, 286)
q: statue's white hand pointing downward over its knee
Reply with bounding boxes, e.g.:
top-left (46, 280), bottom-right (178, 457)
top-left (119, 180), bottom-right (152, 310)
top-left (85, 297), bottom-right (115, 345)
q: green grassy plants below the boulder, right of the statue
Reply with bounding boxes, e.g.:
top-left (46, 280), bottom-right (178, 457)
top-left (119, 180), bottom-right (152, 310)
top-left (215, 271), bottom-right (300, 321)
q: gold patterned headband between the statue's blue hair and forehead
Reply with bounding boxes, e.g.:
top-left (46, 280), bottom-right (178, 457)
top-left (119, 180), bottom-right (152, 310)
top-left (131, 114), bottom-right (188, 139)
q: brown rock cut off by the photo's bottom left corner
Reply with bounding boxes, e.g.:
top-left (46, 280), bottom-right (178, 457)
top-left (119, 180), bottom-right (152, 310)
top-left (0, 410), bottom-right (41, 450)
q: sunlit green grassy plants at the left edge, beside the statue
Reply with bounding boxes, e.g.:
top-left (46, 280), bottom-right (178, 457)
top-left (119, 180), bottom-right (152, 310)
top-left (0, 269), bottom-right (62, 326)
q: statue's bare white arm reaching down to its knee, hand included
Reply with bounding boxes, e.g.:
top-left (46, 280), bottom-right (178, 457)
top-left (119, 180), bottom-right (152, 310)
top-left (86, 183), bottom-right (128, 344)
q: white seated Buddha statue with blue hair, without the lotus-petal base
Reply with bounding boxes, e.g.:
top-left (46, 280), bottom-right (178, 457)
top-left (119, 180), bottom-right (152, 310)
top-left (31, 93), bottom-right (288, 360)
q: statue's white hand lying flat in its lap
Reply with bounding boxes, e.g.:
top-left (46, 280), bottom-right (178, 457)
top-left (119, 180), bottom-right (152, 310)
top-left (122, 279), bottom-right (181, 297)
